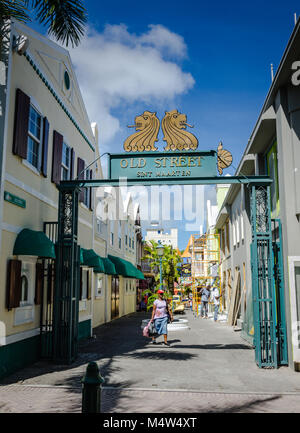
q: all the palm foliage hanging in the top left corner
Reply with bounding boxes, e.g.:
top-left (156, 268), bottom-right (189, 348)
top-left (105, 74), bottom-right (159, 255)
top-left (0, 0), bottom-right (87, 47)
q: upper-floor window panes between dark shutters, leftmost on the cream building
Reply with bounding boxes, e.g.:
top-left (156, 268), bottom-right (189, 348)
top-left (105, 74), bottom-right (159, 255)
top-left (27, 105), bottom-right (42, 170)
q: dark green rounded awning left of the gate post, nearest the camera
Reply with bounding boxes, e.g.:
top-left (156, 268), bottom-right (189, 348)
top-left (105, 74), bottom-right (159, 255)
top-left (13, 229), bottom-right (56, 259)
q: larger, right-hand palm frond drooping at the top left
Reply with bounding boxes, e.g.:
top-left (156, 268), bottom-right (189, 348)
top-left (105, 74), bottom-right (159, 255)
top-left (30, 0), bottom-right (87, 47)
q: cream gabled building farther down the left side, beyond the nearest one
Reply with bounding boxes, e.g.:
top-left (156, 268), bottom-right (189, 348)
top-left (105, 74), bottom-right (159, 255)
top-left (93, 187), bottom-right (139, 327)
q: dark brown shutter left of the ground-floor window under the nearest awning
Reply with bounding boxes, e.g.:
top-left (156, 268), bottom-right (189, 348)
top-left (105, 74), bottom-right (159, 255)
top-left (6, 260), bottom-right (22, 310)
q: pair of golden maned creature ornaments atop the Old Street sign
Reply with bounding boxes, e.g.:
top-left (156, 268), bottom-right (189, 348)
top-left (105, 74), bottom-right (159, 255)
top-left (124, 110), bottom-right (198, 152)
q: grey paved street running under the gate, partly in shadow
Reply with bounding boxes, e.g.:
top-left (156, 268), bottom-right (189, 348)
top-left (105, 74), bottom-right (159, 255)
top-left (0, 311), bottom-right (300, 413)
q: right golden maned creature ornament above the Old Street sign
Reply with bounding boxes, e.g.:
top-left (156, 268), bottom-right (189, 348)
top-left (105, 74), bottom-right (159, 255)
top-left (161, 110), bottom-right (198, 150)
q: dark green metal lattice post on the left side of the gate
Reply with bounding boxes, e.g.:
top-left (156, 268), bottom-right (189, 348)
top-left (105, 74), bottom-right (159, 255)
top-left (53, 186), bottom-right (80, 364)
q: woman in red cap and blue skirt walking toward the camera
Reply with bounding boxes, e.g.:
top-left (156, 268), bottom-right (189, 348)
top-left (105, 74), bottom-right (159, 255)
top-left (151, 290), bottom-right (173, 346)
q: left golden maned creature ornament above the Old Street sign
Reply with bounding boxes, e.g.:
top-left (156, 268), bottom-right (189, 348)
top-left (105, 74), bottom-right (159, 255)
top-left (124, 111), bottom-right (160, 152)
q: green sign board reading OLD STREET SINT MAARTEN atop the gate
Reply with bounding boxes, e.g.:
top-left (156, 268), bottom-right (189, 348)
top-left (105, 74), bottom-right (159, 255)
top-left (109, 150), bottom-right (216, 179)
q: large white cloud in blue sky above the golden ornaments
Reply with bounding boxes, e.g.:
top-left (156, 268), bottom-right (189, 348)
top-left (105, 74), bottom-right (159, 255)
top-left (70, 24), bottom-right (195, 149)
